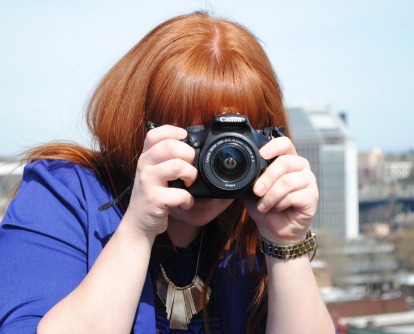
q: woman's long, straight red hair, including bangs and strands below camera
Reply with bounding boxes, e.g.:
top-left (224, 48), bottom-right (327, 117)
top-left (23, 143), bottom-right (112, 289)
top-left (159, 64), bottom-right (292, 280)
top-left (22, 12), bottom-right (287, 330)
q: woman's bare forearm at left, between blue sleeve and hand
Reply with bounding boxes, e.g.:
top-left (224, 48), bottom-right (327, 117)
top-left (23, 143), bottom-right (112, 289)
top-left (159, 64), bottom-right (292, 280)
top-left (38, 218), bottom-right (153, 334)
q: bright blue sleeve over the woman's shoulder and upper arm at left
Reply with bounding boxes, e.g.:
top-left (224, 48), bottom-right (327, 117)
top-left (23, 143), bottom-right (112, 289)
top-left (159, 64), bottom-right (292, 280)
top-left (0, 160), bottom-right (109, 333)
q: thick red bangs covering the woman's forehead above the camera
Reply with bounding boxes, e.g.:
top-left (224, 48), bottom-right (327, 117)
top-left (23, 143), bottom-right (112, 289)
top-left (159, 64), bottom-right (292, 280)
top-left (146, 30), bottom-right (280, 129)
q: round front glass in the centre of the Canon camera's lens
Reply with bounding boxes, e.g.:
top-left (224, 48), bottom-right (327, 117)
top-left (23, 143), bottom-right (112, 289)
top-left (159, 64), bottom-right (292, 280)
top-left (212, 143), bottom-right (250, 182)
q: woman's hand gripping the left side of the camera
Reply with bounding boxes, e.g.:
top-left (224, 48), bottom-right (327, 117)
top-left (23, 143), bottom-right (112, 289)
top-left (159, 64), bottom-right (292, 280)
top-left (125, 125), bottom-right (197, 237)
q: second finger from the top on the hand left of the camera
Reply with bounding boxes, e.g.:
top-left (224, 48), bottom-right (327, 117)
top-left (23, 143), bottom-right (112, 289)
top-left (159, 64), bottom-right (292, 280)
top-left (140, 138), bottom-right (195, 165)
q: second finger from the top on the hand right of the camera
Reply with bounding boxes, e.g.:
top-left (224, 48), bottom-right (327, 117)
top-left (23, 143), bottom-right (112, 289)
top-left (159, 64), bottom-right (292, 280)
top-left (253, 155), bottom-right (310, 197)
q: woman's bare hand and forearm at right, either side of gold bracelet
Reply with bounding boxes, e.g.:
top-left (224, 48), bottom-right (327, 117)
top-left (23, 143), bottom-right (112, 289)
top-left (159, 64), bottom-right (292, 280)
top-left (246, 137), bottom-right (335, 334)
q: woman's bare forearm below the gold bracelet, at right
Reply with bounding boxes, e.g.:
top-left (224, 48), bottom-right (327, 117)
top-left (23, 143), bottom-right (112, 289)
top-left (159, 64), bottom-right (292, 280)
top-left (266, 256), bottom-right (335, 334)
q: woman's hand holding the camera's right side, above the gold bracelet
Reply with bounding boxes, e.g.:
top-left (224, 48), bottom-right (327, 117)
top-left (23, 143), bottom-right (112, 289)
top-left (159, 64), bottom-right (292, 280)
top-left (246, 137), bottom-right (319, 245)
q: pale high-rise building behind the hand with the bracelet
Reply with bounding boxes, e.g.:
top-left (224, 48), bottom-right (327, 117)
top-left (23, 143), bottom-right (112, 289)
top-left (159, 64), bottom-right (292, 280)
top-left (288, 107), bottom-right (359, 240)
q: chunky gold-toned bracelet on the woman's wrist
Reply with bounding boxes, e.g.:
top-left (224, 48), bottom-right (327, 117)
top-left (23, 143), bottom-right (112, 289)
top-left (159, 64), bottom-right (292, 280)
top-left (258, 230), bottom-right (316, 260)
